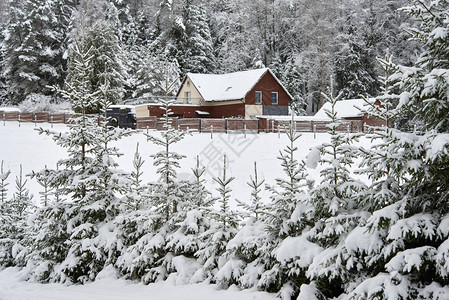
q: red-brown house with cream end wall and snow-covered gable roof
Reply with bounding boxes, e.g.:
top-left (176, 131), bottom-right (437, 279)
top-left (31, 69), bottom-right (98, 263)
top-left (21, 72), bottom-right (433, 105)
top-left (176, 68), bottom-right (292, 119)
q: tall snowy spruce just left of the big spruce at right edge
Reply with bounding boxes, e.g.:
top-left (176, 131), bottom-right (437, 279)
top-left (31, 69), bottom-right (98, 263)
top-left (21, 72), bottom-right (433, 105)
top-left (303, 57), bottom-right (407, 299)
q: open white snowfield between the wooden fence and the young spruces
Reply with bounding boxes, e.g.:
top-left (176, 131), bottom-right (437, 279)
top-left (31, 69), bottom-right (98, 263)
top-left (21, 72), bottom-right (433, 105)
top-left (0, 122), bottom-right (346, 208)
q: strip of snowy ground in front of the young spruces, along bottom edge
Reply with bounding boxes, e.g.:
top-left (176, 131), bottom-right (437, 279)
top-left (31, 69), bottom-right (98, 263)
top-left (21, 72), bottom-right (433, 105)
top-left (0, 268), bottom-right (276, 300)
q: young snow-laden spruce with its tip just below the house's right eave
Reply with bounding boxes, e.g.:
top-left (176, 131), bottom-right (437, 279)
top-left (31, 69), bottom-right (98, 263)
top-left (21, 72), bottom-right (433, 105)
top-left (245, 120), bottom-right (317, 298)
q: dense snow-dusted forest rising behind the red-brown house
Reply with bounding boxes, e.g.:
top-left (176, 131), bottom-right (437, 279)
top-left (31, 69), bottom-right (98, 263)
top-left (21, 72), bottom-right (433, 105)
top-left (0, 0), bottom-right (419, 113)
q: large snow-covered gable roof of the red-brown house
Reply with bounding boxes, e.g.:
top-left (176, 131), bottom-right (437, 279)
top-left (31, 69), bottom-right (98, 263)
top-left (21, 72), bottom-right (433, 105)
top-left (177, 68), bottom-right (293, 101)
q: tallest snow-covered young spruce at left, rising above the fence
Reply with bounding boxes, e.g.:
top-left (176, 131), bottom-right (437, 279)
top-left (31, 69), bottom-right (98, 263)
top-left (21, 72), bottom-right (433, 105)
top-left (27, 46), bottom-right (131, 283)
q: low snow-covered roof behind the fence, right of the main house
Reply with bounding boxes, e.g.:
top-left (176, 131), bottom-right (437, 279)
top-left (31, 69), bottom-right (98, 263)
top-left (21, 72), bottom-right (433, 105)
top-left (315, 99), bottom-right (376, 119)
